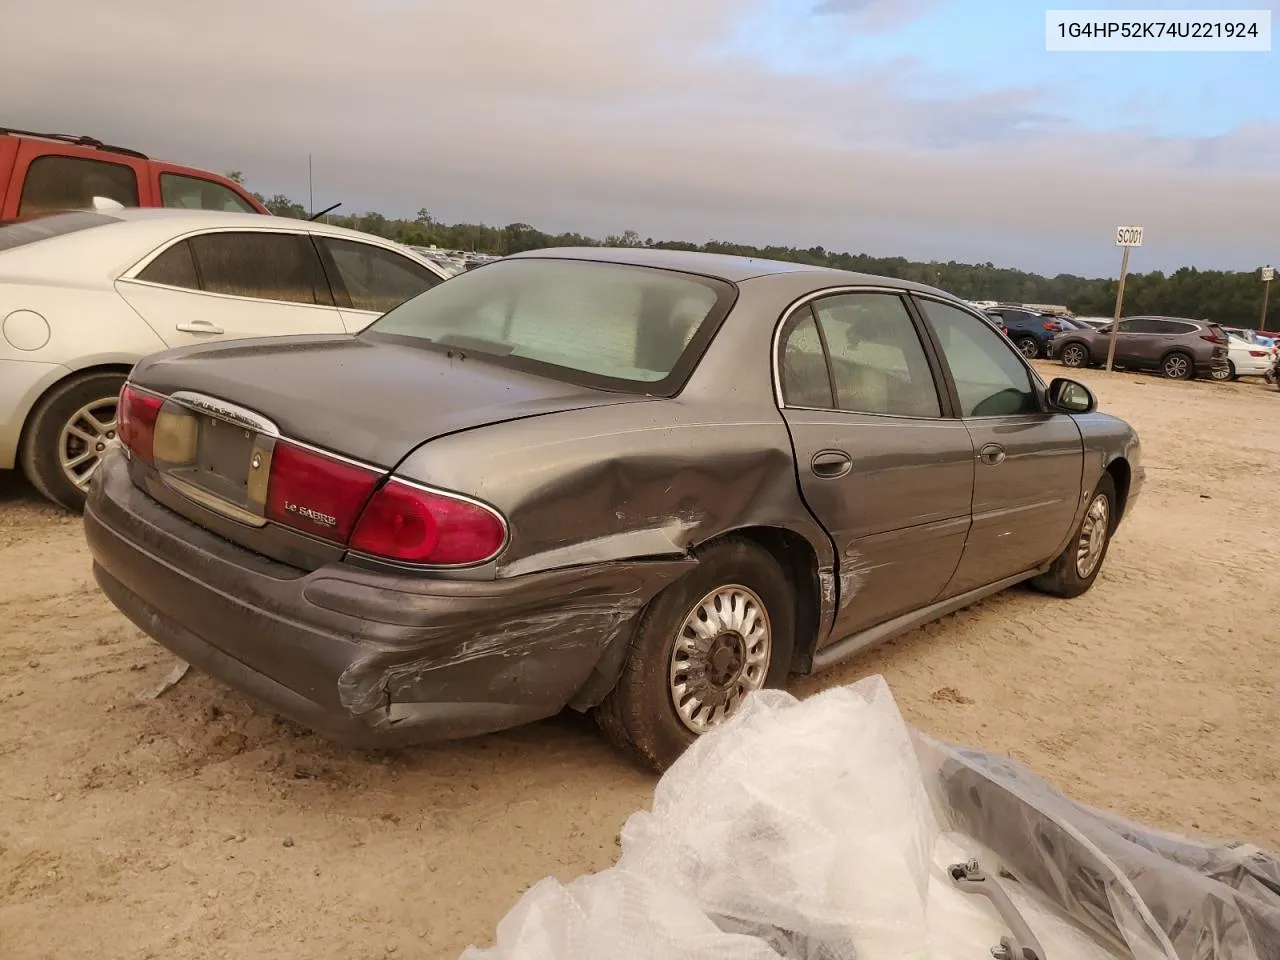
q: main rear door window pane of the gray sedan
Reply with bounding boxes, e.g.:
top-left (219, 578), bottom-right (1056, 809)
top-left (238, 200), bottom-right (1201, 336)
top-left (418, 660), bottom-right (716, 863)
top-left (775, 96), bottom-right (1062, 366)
top-left (813, 293), bottom-right (942, 417)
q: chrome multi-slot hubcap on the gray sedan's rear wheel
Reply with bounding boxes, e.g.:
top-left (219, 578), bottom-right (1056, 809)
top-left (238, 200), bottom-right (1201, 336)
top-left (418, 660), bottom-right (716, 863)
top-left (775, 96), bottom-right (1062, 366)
top-left (669, 585), bottom-right (773, 733)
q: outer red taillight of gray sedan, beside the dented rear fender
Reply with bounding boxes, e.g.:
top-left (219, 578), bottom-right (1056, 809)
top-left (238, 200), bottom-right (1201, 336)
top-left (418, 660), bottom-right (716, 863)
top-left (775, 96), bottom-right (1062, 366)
top-left (349, 480), bottom-right (507, 566)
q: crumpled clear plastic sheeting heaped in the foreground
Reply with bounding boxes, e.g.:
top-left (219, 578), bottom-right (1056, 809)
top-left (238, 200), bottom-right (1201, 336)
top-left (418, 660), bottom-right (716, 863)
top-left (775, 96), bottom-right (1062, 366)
top-left (462, 676), bottom-right (1280, 960)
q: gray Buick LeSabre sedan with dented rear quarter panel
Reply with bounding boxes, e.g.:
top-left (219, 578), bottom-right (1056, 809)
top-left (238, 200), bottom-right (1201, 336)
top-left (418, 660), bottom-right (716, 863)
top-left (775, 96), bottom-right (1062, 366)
top-left (84, 248), bottom-right (1143, 768)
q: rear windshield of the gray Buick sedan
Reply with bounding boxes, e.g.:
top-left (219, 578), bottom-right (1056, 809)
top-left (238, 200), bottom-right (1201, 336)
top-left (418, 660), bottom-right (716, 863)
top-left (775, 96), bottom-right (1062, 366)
top-left (361, 257), bottom-right (736, 396)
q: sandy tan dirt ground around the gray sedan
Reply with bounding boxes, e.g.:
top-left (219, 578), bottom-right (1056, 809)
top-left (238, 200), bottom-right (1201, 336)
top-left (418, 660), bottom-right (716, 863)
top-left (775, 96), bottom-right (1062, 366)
top-left (0, 365), bottom-right (1280, 960)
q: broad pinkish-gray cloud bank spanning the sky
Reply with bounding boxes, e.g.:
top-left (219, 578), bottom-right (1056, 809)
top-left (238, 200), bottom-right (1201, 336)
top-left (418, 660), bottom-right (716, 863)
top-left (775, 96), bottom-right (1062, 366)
top-left (0, 0), bottom-right (1280, 273)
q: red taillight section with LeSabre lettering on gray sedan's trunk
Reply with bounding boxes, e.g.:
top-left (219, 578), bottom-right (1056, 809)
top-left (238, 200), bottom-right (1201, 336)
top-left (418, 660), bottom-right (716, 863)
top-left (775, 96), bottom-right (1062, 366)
top-left (266, 440), bottom-right (383, 543)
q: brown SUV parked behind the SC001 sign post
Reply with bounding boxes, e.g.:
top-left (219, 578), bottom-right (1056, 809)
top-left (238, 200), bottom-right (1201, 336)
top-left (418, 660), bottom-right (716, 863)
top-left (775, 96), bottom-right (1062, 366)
top-left (1048, 316), bottom-right (1230, 380)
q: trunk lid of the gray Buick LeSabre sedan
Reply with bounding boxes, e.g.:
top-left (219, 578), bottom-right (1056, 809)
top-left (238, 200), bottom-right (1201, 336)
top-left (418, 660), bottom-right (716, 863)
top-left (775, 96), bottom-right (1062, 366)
top-left (122, 335), bottom-right (645, 570)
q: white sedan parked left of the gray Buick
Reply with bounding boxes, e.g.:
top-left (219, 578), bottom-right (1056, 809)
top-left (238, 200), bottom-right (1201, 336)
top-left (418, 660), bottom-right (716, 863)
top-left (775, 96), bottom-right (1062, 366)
top-left (0, 209), bottom-right (448, 509)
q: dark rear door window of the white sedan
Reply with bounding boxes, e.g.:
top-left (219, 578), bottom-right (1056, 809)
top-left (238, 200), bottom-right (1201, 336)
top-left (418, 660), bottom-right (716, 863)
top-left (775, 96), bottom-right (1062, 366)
top-left (188, 230), bottom-right (333, 305)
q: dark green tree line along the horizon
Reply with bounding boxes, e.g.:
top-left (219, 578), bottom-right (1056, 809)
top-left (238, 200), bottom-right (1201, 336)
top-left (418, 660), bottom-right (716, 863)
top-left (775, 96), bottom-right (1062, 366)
top-left (228, 172), bottom-right (1280, 329)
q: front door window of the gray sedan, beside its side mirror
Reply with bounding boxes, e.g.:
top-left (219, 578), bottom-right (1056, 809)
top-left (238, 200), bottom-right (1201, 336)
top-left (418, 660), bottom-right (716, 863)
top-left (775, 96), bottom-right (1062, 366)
top-left (919, 298), bottom-right (1042, 417)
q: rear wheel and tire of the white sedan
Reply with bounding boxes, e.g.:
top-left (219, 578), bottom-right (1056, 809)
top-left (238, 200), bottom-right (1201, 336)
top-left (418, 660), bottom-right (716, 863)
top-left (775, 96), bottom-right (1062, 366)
top-left (18, 372), bottom-right (125, 511)
